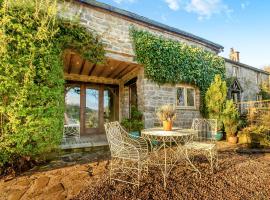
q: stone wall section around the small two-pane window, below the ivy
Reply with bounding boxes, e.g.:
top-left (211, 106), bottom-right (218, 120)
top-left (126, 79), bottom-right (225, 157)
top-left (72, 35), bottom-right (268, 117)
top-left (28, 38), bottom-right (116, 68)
top-left (137, 69), bottom-right (200, 128)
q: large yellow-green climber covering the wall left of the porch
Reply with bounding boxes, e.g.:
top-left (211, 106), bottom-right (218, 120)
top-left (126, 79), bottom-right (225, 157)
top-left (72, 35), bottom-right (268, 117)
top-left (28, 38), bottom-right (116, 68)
top-left (0, 0), bottom-right (105, 168)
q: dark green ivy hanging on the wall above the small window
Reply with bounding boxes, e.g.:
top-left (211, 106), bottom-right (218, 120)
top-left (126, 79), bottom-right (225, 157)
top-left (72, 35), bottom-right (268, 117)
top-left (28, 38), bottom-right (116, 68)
top-left (130, 27), bottom-right (225, 113)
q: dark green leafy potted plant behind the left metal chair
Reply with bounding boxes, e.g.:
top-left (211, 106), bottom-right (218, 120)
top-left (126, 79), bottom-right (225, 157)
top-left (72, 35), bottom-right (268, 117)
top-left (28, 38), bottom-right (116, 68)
top-left (121, 106), bottom-right (144, 138)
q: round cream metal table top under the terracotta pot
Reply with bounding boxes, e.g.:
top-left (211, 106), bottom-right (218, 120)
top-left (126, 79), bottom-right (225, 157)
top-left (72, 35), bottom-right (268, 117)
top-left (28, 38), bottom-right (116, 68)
top-left (141, 127), bottom-right (197, 137)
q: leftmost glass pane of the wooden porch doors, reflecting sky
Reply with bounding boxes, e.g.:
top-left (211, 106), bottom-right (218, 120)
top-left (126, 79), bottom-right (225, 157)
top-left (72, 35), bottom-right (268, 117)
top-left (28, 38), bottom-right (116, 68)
top-left (64, 86), bottom-right (81, 125)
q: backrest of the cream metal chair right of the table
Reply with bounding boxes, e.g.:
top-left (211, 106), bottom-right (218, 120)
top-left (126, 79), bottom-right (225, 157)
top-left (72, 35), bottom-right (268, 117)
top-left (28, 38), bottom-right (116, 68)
top-left (192, 118), bottom-right (217, 142)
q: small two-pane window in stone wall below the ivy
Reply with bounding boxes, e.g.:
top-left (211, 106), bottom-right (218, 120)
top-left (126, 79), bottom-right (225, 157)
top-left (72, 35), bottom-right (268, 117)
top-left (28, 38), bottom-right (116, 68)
top-left (176, 87), bottom-right (195, 108)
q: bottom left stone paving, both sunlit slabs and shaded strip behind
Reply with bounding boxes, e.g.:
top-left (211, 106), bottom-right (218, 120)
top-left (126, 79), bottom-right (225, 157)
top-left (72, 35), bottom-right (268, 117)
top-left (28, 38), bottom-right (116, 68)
top-left (0, 146), bottom-right (109, 200)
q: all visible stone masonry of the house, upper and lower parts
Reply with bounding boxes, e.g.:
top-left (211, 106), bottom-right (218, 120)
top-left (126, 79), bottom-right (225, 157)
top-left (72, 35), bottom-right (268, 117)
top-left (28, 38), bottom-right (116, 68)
top-left (59, 1), bottom-right (270, 128)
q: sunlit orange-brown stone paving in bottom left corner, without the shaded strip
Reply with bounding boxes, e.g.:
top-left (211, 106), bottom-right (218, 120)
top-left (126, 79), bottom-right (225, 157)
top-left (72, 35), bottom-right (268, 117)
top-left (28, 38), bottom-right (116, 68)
top-left (0, 162), bottom-right (107, 200)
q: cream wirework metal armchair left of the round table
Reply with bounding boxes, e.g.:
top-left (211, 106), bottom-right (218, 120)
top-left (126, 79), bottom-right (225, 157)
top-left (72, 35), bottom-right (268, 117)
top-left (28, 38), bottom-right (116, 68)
top-left (104, 121), bottom-right (148, 187)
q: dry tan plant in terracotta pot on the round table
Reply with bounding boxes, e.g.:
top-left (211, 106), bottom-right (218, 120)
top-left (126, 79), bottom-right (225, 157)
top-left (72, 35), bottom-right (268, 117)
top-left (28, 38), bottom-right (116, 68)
top-left (156, 104), bottom-right (175, 131)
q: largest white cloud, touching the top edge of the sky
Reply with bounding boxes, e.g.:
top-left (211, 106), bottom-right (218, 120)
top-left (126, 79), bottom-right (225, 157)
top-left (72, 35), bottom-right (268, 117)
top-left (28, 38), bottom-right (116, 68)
top-left (185, 0), bottom-right (233, 20)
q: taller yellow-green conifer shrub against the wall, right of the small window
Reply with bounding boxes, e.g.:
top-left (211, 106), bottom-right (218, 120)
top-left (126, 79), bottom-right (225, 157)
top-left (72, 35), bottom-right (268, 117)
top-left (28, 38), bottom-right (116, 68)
top-left (205, 75), bottom-right (227, 130)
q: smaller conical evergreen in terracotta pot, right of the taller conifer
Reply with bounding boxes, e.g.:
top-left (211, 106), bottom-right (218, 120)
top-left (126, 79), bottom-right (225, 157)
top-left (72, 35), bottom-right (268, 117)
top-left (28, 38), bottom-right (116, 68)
top-left (223, 100), bottom-right (239, 144)
